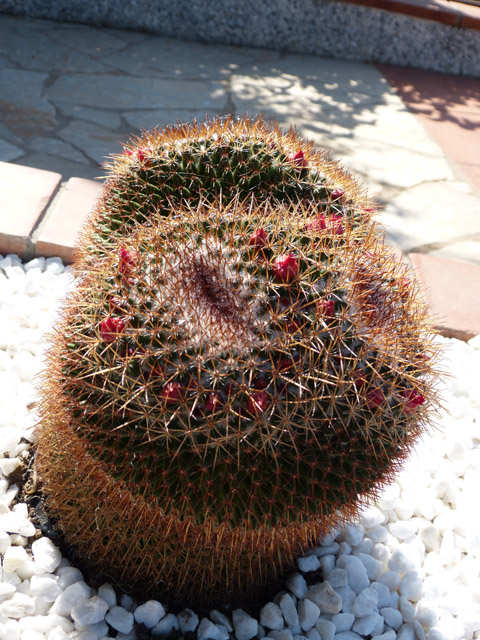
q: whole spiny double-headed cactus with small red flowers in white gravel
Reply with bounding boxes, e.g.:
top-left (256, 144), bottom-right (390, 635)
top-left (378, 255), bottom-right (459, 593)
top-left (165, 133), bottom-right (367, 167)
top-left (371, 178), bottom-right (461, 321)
top-left (36, 119), bottom-right (442, 606)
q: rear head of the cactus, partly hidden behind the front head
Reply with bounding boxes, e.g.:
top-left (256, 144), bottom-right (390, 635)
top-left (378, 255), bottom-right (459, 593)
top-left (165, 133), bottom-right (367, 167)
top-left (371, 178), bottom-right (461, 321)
top-left (77, 117), bottom-right (372, 270)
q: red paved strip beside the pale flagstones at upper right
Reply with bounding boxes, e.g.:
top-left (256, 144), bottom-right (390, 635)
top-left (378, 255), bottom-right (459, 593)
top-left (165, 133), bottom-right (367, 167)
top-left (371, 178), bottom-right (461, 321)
top-left (376, 64), bottom-right (480, 192)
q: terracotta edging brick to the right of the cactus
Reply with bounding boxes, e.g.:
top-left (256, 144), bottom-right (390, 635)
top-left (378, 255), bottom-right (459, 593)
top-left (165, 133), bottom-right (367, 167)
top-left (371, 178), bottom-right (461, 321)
top-left (409, 253), bottom-right (480, 340)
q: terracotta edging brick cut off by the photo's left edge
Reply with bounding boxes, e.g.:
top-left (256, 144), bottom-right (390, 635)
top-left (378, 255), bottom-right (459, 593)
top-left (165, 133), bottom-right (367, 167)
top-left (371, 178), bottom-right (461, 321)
top-left (0, 162), bottom-right (62, 259)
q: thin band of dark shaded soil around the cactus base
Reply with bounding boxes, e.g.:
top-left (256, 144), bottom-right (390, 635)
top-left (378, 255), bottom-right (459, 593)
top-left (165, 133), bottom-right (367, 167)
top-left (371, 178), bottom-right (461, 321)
top-left (9, 446), bottom-right (324, 640)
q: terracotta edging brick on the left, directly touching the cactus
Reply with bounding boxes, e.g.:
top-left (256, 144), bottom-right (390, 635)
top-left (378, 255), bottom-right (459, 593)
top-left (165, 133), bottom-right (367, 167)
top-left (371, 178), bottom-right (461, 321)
top-left (35, 178), bottom-right (102, 262)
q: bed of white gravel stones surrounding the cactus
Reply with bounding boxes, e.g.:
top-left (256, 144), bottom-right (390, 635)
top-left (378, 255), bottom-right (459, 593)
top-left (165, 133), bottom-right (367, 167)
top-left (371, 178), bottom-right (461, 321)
top-left (0, 255), bottom-right (480, 640)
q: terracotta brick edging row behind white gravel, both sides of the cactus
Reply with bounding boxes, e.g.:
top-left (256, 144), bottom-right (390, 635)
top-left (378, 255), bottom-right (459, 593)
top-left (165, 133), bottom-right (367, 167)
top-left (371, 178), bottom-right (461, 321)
top-left (0, 162), bottom-right (480, 340)
